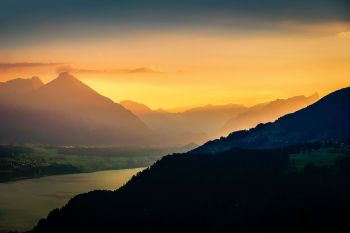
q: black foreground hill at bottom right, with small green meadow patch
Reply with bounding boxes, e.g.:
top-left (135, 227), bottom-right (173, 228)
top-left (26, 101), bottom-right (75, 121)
top-left (28, 143), bottom-right (350, 233)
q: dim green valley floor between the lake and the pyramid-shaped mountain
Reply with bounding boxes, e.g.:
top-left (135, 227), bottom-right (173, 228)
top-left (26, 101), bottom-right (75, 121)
top-left (0, 145), bottom-right (193, 182)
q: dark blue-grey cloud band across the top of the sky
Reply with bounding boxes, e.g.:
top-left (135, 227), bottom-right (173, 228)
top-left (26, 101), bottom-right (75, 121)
top-left (0, 0), bottom-right (350, 45)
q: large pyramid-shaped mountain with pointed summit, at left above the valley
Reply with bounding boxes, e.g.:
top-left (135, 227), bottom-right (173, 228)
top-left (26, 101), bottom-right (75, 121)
top-left (0, 73), bottom-right (153, 145)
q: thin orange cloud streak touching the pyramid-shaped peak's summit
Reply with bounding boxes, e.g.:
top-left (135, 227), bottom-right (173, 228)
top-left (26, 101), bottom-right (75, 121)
top-left (56, 65), bottom-right (165, 74)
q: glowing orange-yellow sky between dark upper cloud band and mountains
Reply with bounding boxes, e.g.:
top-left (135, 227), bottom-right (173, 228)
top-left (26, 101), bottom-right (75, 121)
top-left (0, 23), bottom-right (350, 109)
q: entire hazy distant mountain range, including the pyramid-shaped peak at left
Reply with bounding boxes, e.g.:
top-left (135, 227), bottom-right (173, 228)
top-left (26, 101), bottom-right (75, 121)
top-left (0, 73), bottom-right (318, 146)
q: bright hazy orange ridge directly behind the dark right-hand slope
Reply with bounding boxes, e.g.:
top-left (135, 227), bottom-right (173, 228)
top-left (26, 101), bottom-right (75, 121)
top-left (218, 93), bottom-right (318, 136)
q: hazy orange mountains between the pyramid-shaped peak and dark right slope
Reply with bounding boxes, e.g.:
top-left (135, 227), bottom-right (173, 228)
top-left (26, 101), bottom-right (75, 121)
top-left (120, 94), bottom-right (318, 144)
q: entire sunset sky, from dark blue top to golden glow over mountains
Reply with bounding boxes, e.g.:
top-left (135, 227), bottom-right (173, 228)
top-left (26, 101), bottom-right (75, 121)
top-left (0, 0), bottom-right (350, 109)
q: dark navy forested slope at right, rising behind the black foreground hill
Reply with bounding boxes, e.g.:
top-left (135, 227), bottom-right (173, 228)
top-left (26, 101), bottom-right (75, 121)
top-left (192, 87), bottom-right (350, 153)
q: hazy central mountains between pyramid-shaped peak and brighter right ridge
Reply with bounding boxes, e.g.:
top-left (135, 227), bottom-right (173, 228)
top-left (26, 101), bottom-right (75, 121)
top-left (120, 100), bottom-right (246, 145)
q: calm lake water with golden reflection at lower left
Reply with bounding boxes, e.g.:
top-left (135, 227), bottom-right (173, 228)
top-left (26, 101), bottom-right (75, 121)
top-left (0, 168), bottom-right (143, 232)
